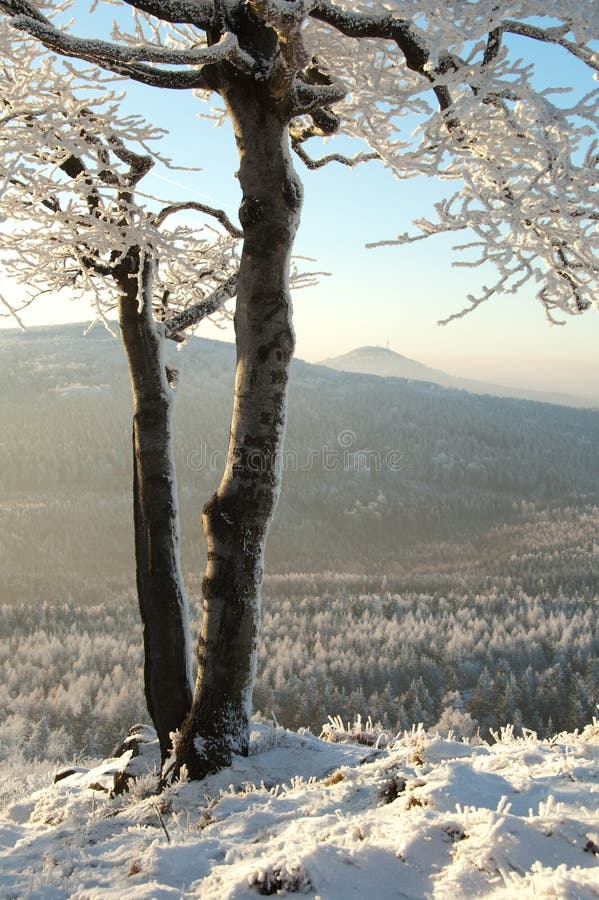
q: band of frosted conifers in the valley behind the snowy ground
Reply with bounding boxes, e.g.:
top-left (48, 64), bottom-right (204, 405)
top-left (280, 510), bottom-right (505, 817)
top-left (0, 575), bottom-right (599, 760)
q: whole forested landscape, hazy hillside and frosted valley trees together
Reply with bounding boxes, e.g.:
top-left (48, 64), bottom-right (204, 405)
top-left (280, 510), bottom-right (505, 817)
top-left (0, 326), bottom-right (599, 759)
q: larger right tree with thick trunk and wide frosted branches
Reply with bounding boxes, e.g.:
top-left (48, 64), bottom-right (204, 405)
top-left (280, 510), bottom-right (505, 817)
top-left (0, 0), bottom-right (599, 778)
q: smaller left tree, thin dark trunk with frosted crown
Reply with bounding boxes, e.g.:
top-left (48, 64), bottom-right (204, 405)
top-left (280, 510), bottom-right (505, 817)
top-left (0, 22), bottom-right (241, 758)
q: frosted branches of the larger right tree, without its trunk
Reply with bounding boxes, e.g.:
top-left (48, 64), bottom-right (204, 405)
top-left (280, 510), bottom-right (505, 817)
top-left (0, 0), bottom-right (599, 321)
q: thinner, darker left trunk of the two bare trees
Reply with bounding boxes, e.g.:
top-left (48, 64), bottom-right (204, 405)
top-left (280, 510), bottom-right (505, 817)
top-left (117, 248), bottom-right (192, 761)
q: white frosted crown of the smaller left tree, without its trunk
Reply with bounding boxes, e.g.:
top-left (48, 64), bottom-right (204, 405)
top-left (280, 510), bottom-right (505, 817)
top-left (0, 21), bottom-right (239, 320)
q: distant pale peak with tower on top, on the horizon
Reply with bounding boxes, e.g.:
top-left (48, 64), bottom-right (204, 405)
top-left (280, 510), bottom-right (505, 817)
top-left (320, 347), bottom-right (594, 407)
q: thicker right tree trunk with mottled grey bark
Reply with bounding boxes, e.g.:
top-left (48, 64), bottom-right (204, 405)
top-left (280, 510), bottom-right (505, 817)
top-left (176, 77), bottom-right (302, 779)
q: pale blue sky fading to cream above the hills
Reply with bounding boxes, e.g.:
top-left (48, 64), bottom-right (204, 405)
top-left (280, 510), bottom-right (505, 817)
top-left (0, 5), bottom-right (599, 399)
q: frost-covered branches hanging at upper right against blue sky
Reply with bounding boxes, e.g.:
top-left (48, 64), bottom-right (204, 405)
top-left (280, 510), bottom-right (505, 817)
top-left (308, 0), bottom-right (599, 321)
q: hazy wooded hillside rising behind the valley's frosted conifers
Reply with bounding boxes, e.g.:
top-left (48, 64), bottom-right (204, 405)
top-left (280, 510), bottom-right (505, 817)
top-left (0, 326), bottom-right (599, 584)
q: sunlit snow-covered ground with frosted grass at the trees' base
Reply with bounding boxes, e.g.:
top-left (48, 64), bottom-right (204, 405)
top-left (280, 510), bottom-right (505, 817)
top-left (0, 722), bottom-right (599, 900)
